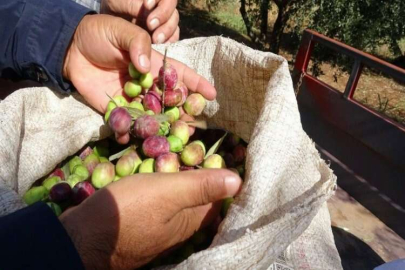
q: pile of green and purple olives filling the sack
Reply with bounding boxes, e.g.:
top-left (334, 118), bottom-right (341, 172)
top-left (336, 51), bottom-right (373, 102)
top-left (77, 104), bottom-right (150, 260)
top-left (23, 52), bottom-right (247, 268)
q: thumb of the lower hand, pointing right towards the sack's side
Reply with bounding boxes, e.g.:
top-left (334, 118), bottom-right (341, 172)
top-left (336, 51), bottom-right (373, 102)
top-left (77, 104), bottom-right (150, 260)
top-left (165, 169), bottom-right (242, 211)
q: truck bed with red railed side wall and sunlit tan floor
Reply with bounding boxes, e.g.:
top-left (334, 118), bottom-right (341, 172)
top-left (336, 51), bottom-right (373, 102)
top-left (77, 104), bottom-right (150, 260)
top-left (293, 30), bottom-right (405, 270)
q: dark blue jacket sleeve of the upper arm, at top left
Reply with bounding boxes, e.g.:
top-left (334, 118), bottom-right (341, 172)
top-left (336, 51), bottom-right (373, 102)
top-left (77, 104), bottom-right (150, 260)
top-left (0, 0), bottom-right (94, 92)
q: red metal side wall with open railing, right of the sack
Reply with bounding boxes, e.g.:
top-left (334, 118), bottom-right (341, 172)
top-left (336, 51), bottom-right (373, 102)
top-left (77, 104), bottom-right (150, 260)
top-left (293, 30), bottom-right (405, 269)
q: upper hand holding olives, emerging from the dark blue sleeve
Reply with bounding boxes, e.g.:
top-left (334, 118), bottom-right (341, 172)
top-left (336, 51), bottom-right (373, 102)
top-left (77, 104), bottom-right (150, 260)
top-left (63, 15), bottom-right (216, 113)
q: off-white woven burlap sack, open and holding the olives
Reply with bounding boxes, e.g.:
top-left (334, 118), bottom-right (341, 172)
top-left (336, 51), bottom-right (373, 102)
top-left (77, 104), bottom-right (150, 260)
top-left (0, 37), bottom-right (341, 270)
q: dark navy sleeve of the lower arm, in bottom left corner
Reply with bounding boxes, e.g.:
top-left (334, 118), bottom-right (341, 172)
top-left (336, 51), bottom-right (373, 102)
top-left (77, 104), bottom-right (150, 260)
top-left (0, 202), bottom-right (84, 270)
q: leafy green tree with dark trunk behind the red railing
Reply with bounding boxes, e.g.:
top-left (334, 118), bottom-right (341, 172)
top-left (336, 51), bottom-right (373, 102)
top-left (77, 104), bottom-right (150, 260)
top-left (240, 0), bottom-right (405, 56)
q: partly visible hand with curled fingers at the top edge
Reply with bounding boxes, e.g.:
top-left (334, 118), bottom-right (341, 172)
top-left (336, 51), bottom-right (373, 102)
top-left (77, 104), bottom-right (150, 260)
top-left (101, 0), bottom-right (180, 44)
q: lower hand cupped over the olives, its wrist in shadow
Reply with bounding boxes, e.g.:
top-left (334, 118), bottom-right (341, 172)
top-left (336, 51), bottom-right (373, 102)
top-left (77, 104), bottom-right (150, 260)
top-left (60, 169), bottom-right (242, 269)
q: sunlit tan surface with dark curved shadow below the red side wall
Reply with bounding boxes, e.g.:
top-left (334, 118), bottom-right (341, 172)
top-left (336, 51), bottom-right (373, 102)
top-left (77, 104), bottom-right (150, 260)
top-left (328, 188), bottom-right (405, 270)
